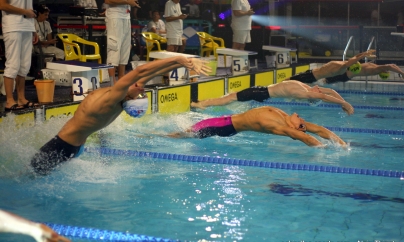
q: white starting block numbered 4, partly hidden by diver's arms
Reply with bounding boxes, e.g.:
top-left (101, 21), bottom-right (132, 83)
top-left (149, 51), bottom-right (199, 82)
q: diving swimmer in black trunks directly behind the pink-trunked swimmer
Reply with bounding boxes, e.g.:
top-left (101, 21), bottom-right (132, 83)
top-left (191, 81), bottom-right (354, 115)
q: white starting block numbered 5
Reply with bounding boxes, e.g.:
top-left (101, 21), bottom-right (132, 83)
top-left (216, 48), bottom-right (257, 76)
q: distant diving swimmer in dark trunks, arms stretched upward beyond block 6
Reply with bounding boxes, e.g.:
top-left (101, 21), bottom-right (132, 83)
top-left (286, 50), bottom-right (375, 83)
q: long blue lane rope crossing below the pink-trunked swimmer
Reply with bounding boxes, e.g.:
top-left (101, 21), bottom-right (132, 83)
top-left (84, 147), bottom-right (404, 179)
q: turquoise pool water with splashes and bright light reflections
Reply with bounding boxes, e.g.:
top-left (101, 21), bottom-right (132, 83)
top-left (0, 91), bottom-right (404, 241)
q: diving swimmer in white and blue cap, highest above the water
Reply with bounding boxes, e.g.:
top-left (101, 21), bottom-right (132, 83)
top-left (31, 56), bottom-right (211, 175)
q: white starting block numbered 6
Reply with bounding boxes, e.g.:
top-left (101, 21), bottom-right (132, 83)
top-left (262, 45), bottom-right (297, 68)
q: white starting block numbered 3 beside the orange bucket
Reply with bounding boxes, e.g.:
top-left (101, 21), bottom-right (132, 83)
top-left (46, 61), bottom-right (113, 101)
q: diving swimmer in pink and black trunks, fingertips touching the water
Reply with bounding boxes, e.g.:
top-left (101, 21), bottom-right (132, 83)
top-left (164, 106), bottom-right (346, 148)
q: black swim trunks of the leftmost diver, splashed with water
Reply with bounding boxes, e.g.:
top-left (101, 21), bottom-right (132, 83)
top-left (31, 136), bottom-right (83, 175)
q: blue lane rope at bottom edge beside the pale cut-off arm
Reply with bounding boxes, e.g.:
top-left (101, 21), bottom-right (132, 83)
top-left (44, 223), bottom-right (179, 242)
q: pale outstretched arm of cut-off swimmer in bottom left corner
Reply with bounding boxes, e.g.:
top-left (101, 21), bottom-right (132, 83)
top-left (0, 210), bottom-right (70, 242)
